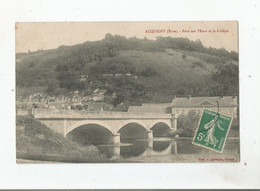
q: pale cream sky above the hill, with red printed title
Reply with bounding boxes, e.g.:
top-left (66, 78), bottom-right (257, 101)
top-left (15, 21), bottom-right (238, 53)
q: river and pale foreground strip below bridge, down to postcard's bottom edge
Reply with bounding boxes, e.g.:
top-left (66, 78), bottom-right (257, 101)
top-left (97, 138), bottom-right (239, 162)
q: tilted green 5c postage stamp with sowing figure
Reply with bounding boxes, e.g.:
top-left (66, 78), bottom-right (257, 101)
top-left (193, 109), bottom-right (232, 153)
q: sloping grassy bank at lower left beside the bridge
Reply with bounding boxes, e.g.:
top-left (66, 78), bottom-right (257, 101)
top-left (16, 116), bottom-right (107, 163)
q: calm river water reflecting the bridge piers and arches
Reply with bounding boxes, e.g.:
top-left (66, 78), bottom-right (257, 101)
top-left (98, 139), bottom-right (239, 158)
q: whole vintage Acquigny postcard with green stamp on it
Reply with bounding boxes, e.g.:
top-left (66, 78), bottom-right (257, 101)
top-left (15, 21), bottom-right (240, 163)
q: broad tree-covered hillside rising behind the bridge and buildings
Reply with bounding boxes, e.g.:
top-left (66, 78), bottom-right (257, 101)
top-left (16, 34), bottom-right (238, 106)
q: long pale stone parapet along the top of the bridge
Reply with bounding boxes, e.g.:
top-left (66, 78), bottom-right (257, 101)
top-left (31, 108), bottom-right (172, 119)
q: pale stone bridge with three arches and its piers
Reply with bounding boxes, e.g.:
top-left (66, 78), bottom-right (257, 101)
top-left (31, 108), bottom-right (177, 143)
